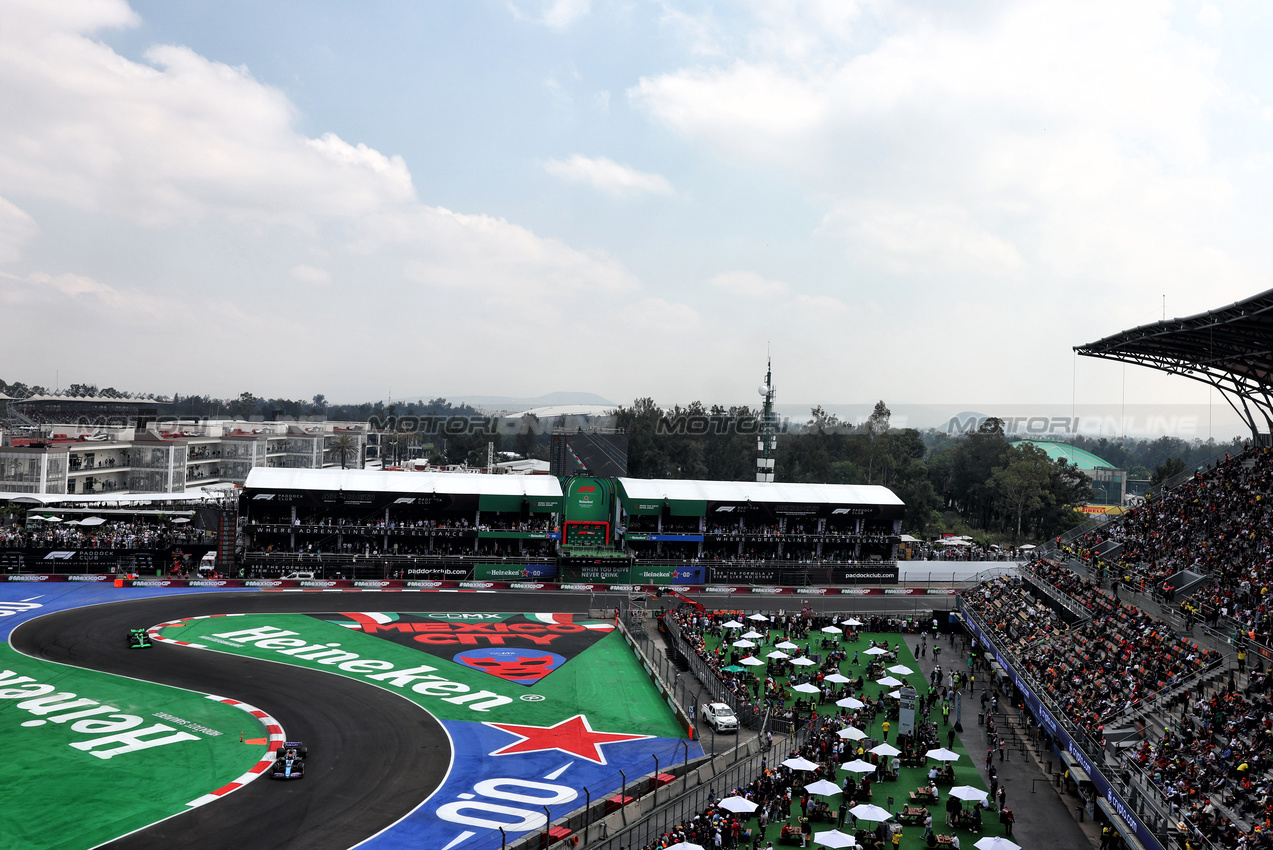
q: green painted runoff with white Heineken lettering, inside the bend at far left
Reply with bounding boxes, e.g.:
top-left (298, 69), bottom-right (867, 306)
top-left (0, 643), bottom-right (266, 850)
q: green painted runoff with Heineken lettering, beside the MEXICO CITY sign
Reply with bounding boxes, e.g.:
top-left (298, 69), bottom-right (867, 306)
top-left (160, 613), bottom-right (686, 738)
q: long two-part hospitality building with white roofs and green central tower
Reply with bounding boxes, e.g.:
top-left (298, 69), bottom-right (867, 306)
top-left (238, 468), bottom-right (905, 587)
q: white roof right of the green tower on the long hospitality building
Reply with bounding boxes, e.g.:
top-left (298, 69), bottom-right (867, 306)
top-left (619, 478), bottom-right (905, 505)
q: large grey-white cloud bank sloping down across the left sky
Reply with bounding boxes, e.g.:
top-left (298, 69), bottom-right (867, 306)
top-left (0, 1), bottom-right (677, 397)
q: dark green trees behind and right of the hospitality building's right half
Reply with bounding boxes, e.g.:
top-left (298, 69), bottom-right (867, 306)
top-left (615, 398), bottom-right (1240, 541)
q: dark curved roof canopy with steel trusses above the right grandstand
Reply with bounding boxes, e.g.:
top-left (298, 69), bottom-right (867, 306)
top-left (1074, 290), bottom-right (1273, 434)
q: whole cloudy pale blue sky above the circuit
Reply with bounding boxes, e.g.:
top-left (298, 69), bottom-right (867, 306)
top-left (0, 0), bottom-right (1273, 408)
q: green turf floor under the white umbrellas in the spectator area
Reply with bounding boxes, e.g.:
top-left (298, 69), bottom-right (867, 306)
top-left (705, 629), bottom-right (1012, 850)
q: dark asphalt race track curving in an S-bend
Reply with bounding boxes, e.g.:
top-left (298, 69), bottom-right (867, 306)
top-left (10, 592), bottom-right (948, 850)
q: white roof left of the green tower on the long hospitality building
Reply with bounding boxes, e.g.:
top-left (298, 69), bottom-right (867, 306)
top-left (243, 467), bottom-right (561, 499)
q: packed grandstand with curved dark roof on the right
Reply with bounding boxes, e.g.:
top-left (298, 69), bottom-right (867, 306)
top-left (960, 291), bottom-right (1273, 850)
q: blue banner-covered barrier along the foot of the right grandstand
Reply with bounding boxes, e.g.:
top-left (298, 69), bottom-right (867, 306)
top-left (959, 597), bottom-right (1175, 850)
